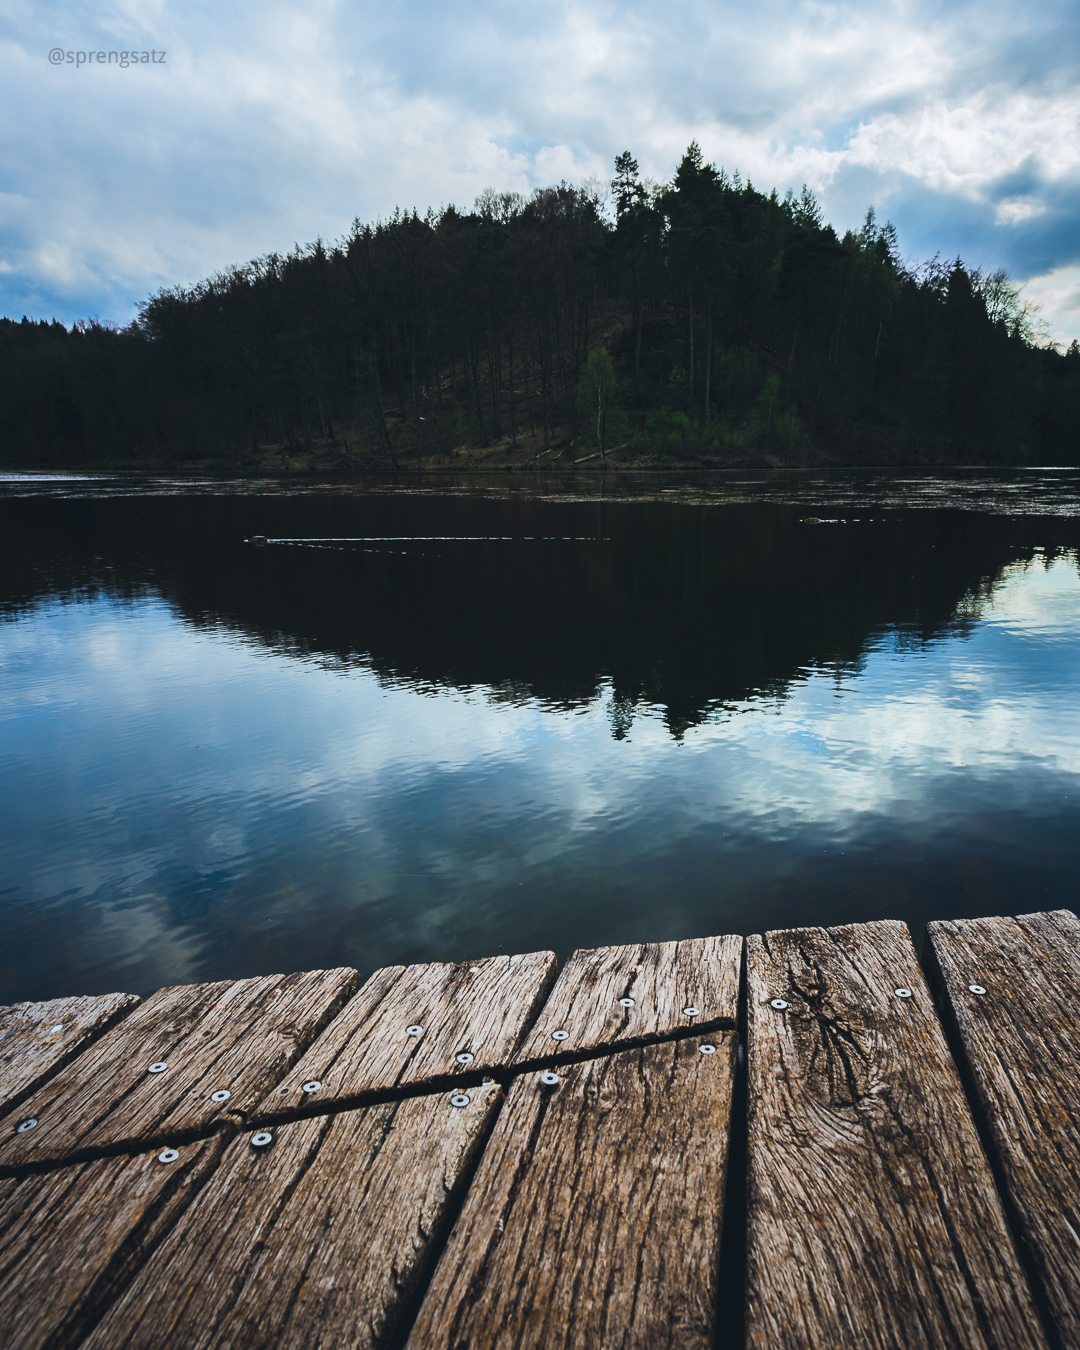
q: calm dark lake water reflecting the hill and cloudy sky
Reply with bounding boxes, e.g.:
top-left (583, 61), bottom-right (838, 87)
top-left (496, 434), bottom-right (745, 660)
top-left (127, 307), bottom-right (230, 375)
top-left (0, 471), bottom-right (1080, 1002)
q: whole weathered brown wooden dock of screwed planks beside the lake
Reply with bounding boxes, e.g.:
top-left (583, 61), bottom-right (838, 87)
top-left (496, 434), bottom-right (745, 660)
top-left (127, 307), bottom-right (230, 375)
top-left (0, 911), bottom-right (1080, 1350)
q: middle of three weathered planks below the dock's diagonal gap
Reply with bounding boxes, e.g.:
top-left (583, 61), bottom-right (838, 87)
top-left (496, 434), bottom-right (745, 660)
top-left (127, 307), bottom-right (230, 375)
top-left (84, 1084), bottom-right (502, 1350)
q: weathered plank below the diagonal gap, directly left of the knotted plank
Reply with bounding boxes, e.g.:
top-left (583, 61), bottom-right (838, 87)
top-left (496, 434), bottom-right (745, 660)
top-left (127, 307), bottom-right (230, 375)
top-left (408, 1031), bottom-right (737, 1350)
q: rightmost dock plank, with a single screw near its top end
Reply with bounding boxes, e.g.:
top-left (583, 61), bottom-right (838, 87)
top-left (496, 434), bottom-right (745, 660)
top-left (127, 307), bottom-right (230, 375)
top-left (926, 910), bottom-right (1080, 1346)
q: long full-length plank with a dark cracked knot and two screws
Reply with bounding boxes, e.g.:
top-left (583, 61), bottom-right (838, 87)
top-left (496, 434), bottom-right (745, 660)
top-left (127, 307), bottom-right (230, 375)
top-left (747, 922), bottom-right (1046, 1350)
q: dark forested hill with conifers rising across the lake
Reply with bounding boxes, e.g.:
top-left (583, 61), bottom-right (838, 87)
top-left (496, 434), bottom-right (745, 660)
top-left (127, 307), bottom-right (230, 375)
top-left (0, 144), bottom-right (1080, 471)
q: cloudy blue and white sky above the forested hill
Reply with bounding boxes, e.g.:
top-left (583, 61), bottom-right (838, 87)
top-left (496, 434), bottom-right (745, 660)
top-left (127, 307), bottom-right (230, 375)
top-left (0, 0), bottom-right (1080, 343)
